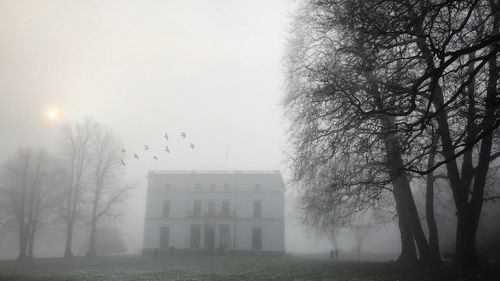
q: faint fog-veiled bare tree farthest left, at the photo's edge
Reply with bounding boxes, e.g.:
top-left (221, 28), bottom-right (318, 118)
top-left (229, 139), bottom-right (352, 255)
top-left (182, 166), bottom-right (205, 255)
top-left (0, 148), bottom-right (58, 260)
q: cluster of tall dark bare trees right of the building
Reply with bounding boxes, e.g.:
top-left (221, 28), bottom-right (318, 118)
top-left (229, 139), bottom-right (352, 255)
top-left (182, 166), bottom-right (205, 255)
top-left (284, 0), bottom-right (500, 268)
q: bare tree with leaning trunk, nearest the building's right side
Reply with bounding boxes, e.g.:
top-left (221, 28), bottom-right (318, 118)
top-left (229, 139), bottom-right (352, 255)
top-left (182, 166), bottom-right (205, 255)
top-left (286, 1), bottom-right (429, 262)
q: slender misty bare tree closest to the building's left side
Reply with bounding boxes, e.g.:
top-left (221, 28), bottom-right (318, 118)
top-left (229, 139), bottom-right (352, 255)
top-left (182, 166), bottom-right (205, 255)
top-left (87, 125), bottom-right (131, 256)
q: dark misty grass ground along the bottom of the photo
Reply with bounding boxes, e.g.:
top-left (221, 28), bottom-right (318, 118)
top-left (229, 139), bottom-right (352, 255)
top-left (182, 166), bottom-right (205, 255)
top-left (0, 255), bottom-right (500, 281)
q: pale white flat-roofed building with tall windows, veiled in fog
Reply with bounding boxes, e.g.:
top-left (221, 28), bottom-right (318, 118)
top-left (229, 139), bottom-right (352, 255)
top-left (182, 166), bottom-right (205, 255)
top-left (143, 171), bottom-right (285, 253)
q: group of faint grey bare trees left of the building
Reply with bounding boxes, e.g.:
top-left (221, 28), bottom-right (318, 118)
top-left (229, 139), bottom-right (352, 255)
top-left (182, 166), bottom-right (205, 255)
top-left (0, 118), bottom-right (131, 260)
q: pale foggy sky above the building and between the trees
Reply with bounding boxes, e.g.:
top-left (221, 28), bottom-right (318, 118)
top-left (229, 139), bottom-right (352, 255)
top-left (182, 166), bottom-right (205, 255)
top-left (0, 0), bottom-right (398, 254)
